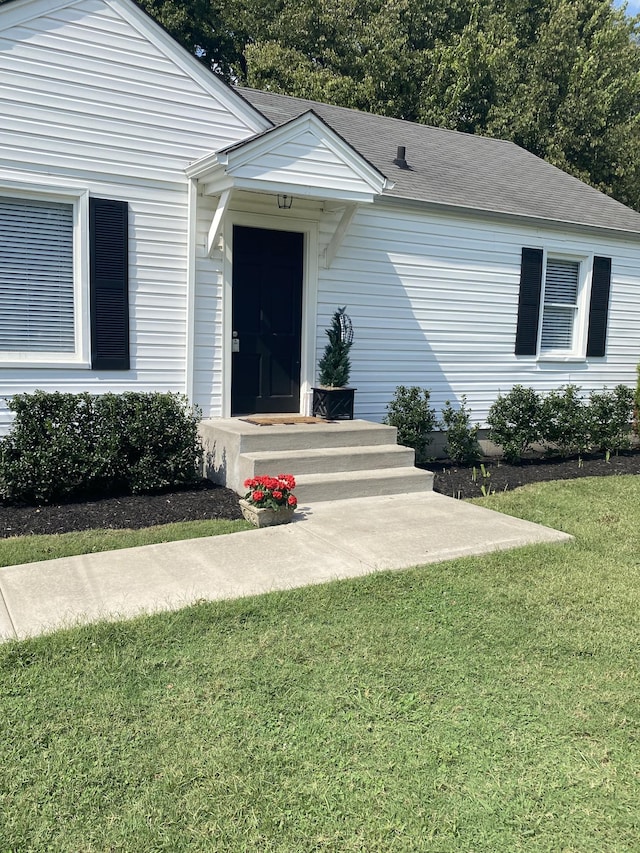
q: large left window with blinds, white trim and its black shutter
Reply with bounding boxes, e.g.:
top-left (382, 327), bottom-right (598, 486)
top-left (0, 191), bottom-right (129, 370)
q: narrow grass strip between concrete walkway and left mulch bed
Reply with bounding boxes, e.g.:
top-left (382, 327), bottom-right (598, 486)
top-left (0, 520), bottom-right (251, 567)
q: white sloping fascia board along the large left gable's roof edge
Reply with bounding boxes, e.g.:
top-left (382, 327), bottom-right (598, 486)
top-left (103, 0), bottom-right (272, 133)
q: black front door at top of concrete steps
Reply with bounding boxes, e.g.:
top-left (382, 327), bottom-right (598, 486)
top-left (231, 225), bottom-right (304, 415)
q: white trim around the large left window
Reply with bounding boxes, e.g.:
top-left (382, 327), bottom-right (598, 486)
top-left (0, 183), bottom-right (91, 369)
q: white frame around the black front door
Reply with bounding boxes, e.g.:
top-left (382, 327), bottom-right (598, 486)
top-left (222, 210), bottom-right (318, 418)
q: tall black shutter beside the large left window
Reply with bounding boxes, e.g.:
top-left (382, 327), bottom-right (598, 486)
top-left (89, 198), bottom-right (129, 370)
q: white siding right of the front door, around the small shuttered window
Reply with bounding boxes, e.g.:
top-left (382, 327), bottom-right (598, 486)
top-left (317, 207), bottom-right (640, 422)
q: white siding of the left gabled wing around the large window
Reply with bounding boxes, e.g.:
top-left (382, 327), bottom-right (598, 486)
top-left (0, 0), bottom-right (257, 432)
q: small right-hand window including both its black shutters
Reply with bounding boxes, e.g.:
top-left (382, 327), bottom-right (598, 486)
top-left (515, 248), bottom-right (611, 358)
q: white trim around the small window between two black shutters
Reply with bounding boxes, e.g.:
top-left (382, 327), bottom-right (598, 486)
top-left (536, 249), bottom-right (594, 361)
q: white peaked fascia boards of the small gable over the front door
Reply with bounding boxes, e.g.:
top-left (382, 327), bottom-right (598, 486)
top-left (224, 112), bottom-right (392, 194)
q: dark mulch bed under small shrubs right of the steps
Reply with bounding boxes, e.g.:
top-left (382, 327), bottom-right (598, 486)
top-left (420, 450), bottom-right (640, 499)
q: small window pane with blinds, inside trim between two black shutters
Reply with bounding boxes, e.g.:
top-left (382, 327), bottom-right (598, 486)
top-left (540, 258), bottom-right (580, 352)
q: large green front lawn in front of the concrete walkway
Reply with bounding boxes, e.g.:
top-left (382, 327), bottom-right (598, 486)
top-left (0, 477), bottom-right (640, 853)
